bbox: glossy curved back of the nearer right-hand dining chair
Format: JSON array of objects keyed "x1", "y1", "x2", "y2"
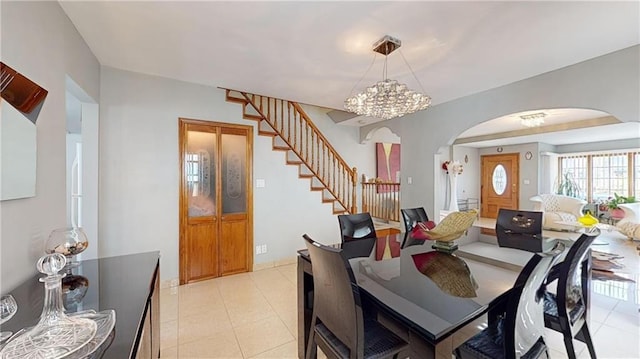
[{"x1": 504, "y1": 242, "x2": 565, "y2": 358}]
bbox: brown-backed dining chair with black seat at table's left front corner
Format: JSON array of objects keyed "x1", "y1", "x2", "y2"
[{"x1": 303, "y1": 234, "x2": 408, "y2": 359}]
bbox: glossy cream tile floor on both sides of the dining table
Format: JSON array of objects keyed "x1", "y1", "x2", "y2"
[{"x1": 161, "y1": 232, "x2": 640, "y2": 359}]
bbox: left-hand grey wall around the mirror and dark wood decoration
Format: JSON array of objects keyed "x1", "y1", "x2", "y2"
[{"x1": 0, "y1": 1, "x2": 100, "y2": 293}]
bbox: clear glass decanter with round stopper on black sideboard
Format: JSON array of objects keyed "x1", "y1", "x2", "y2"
[{"x1": 0, "y1": 253, "x2": 97, "y2": 359}]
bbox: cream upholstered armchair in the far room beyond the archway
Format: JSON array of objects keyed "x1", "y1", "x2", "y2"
[{"x1": 529, "y1": 194, "x2": 587, "y2": 231}]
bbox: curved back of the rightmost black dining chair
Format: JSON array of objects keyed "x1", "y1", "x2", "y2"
[{"x1": 554, "y1": 230, "x2": 600, "y2": 334}]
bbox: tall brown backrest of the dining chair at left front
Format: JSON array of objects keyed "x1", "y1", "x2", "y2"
[{"x1": 303, "y1": 234, "x2": 364, "y2": 357}]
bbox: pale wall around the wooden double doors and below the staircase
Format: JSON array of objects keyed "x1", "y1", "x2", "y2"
[{"x1": 99, "y1": 67, "x2": 375, "y2": 280}]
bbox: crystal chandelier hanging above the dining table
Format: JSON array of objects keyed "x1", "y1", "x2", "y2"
[{"x1": 344, "y1": 35, "x2": 431, "y2": 120}]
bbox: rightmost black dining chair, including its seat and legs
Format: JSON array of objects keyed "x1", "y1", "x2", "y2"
[{"x1": 544, "y1": 230, "x2": 600, "y2": 359}]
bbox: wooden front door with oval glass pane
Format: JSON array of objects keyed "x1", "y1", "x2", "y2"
[{"x1": 480, "y1": 153, "x2": 520, "y2": 222}]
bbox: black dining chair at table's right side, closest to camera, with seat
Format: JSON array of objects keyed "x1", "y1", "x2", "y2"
[{"x1": 454, "y1": 243, "x2": 564, "y2": 359}]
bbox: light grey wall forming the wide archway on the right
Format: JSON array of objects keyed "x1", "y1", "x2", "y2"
[{"x1": 360, "y1": 46, "x2": 640, "y2": 219}]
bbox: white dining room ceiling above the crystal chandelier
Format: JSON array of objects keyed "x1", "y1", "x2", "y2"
[{"x1": 61, "y1": 1, "x2": 640, "y2": 142}]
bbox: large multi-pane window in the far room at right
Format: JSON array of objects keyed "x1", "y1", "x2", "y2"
[{"x1": 559, "y1": 152, "x2": 640, "y2": 202}]
